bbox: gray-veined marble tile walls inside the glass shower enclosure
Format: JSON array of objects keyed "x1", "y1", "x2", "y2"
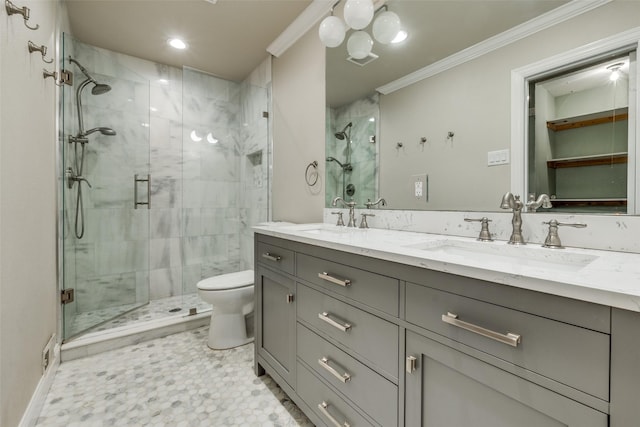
[{"x1": 61, "y1": 38, "x2": 269, "y2": 332}]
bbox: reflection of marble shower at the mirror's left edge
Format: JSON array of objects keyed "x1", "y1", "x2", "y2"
[{"x1": 325, "y1": 95, "x2": 379, "y2": 207}]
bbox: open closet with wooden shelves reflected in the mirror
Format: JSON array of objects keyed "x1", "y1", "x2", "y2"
[{"x1": 527, "y1": 52, "x2": 633, "y2": 213}]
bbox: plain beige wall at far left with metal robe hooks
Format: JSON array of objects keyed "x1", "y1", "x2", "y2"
[{"x1": 0, "y1": 1, "x2": 58, "y2": 426}]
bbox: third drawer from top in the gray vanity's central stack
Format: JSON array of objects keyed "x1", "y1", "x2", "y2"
[{"x1": 297, "y1": 323, "x2": 398, "y2": 426}]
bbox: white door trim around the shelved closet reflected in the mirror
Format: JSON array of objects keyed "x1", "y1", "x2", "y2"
[{"x1": 511, "y1": 27, "x2": 640, "y2": 215}]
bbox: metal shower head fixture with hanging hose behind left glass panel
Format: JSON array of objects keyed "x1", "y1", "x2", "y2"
[{"x1": 65, "y1": 57, "x2": 116, "y2": 239}]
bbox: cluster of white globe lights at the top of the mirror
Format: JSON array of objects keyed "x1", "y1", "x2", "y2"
[{"x1": 318, "y1": 0, "x2": 407, "y2": 65}]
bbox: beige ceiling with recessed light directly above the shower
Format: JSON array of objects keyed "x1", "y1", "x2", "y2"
[{"x1": 65, "y1": 0, "x2": 311, "y2": 81}]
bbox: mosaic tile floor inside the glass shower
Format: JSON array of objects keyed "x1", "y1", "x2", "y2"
[{"x1": 69, "y1": 293, "x2": 211, "y2": 335}]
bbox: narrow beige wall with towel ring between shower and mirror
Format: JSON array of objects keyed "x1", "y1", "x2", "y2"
[{"x1": 273, "y1": 28, "x2": 325, "y2": 222}]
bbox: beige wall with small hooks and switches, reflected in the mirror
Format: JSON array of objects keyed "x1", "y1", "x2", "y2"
[{"x1": 380, "y1": 0, "x2": 640, "y2": 211}]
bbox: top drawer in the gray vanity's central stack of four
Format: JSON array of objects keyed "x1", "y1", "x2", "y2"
[{"x1": 296, "y1": 254, "x2": 400, "y2": 316}]
